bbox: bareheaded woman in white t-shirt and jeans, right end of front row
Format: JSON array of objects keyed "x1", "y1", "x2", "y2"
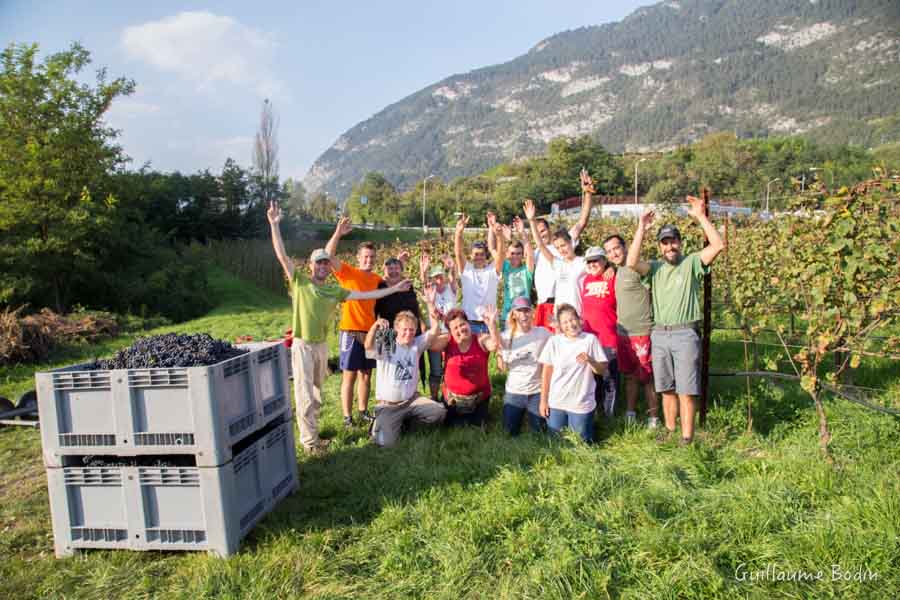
[{"x1": 538, "y1": 304, "x2": 606, "y2": 443}]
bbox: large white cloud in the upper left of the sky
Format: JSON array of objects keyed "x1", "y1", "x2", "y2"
[{"x1": 122, "y1": 12, "x2": 283, "y2": 98}]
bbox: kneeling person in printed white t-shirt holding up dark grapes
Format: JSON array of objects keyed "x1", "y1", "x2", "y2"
[{"x1": 365, "y1": 286, "x2": 447, "y2": 446}]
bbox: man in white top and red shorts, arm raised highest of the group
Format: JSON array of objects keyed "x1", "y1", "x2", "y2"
[{"x1": 534, "y1": 169, "x2": 594, "y2": 331}]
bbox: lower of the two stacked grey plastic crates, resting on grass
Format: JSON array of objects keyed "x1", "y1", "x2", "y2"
[{"x1": 47, "y1": 419, "x2": 298, "y2": 557}]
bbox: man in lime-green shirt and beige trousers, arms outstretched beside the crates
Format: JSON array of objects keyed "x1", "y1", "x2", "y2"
[{"x1": 266, "y1": 202, "x2": 410, "y2": 454}]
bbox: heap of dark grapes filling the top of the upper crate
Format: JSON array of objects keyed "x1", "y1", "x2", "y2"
[{"x1": 87, "y1": 333, "x2": 249, "y2": 370}]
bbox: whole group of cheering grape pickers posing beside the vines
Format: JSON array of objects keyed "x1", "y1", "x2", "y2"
[{"x1": 268, "y1": 171, "x2": 724, "y2": 453}]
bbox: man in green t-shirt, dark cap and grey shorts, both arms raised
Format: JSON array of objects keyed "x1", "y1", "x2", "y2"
[{"x1": 626, "y1": 196, "x2": 725, "y2": 444}]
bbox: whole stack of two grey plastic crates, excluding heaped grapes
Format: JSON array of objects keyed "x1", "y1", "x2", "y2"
[{"x1": 35, "y1": 342, "x2": 298, "y2": 556}]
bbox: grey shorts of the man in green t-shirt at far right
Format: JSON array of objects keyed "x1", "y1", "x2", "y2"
[{"x1": 650, "y1": 329, "x2": 700, "y2": 396}]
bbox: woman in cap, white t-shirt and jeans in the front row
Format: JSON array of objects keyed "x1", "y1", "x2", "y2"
[{"x1": 497, "y1": 296, "x2": 552, "y2": 435}]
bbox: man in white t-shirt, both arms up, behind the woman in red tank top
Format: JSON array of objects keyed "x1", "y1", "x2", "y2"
[{"x1": 453, "y1": 214, "x2": 506, "y2": 336}]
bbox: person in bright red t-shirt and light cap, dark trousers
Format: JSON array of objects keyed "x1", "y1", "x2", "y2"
[{"x1": 578, "y1": 246, "x2": 619, "y2": 417}]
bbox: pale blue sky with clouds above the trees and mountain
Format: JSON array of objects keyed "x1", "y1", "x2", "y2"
[{"x1": 0, "y1": 0, "x2": 653, "y2": 179}]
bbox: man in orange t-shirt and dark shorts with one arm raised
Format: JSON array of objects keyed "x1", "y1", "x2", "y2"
[{"x1": 325, "y1": 217, "x2": 381, "y2": 427}]
